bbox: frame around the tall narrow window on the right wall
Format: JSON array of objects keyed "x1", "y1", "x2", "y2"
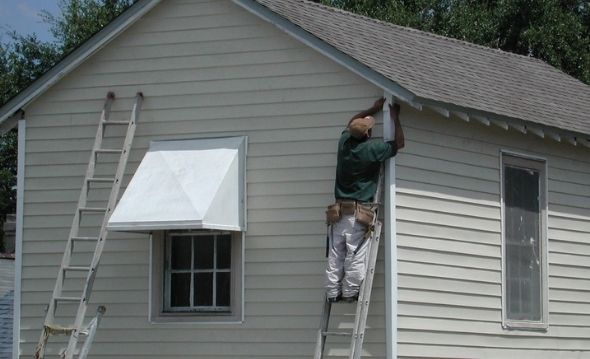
[{"x1": 500, "y1": 150, "x2": 549, "y2": 330}]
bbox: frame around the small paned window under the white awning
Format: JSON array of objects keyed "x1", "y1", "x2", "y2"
[{"x1": 153, "y1": 229, "x2": 245, "y2": 324}]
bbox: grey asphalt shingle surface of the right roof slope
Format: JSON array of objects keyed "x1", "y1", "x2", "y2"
[{"x1": 255, "y1": 0, "x2": 590, "y2": 134}]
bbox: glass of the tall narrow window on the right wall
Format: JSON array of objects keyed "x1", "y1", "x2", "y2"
[{"x1": 504, "y1": 166, "x2": 541, "y2": 321}]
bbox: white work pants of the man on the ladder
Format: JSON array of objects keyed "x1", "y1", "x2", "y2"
[{"x1": 325, "y1": 215, "x2": 369, "y2": 298}]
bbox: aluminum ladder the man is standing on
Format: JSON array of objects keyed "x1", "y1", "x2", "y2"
[{"x1": 314, "y1": 166, "x2": 384, "y2": 359}]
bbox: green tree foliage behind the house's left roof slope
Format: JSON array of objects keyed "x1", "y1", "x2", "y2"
[{"x1": 0, "y1": 0, "x2": 133, "y2": 252}]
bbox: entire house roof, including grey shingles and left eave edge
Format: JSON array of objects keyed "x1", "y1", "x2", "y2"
[{"x1": 0, "y1": 0, "x2": 590, "y2": 141}]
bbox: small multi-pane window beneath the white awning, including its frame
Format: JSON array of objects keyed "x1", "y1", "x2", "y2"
[{"x1": 151, "y1": 230, "x2": 242, "y2": 322}]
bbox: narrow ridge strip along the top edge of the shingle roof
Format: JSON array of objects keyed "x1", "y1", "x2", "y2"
[{"x1": 298, "y1": 0, "x2": 545, "y2": 64}]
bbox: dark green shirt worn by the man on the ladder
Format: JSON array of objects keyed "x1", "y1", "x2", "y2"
[{"x1": 334, "y1": 130, "x2": 397, "y2": 202}]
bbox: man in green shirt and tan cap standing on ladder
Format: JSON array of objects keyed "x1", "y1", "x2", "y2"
[{"x1": 325, "y1": 98, "x2": 404, "y2": 303}]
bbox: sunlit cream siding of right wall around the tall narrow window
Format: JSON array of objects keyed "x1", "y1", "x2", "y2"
[{"x1": 397, "y1": 108, "x2": 590, "y2": 358}]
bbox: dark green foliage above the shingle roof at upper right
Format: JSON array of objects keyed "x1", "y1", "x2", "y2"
[{"x1": 321, "y1": 0, "x2": 590, "y2": 84}]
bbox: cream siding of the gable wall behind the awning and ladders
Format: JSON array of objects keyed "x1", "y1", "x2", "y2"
[{"x1": 21, "y1": 0, "x2": 384, "y2": 359}]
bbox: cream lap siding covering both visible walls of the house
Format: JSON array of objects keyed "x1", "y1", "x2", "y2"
[{"x1": 15, "y1": 0, "x2": 590, "y2": 359}]
